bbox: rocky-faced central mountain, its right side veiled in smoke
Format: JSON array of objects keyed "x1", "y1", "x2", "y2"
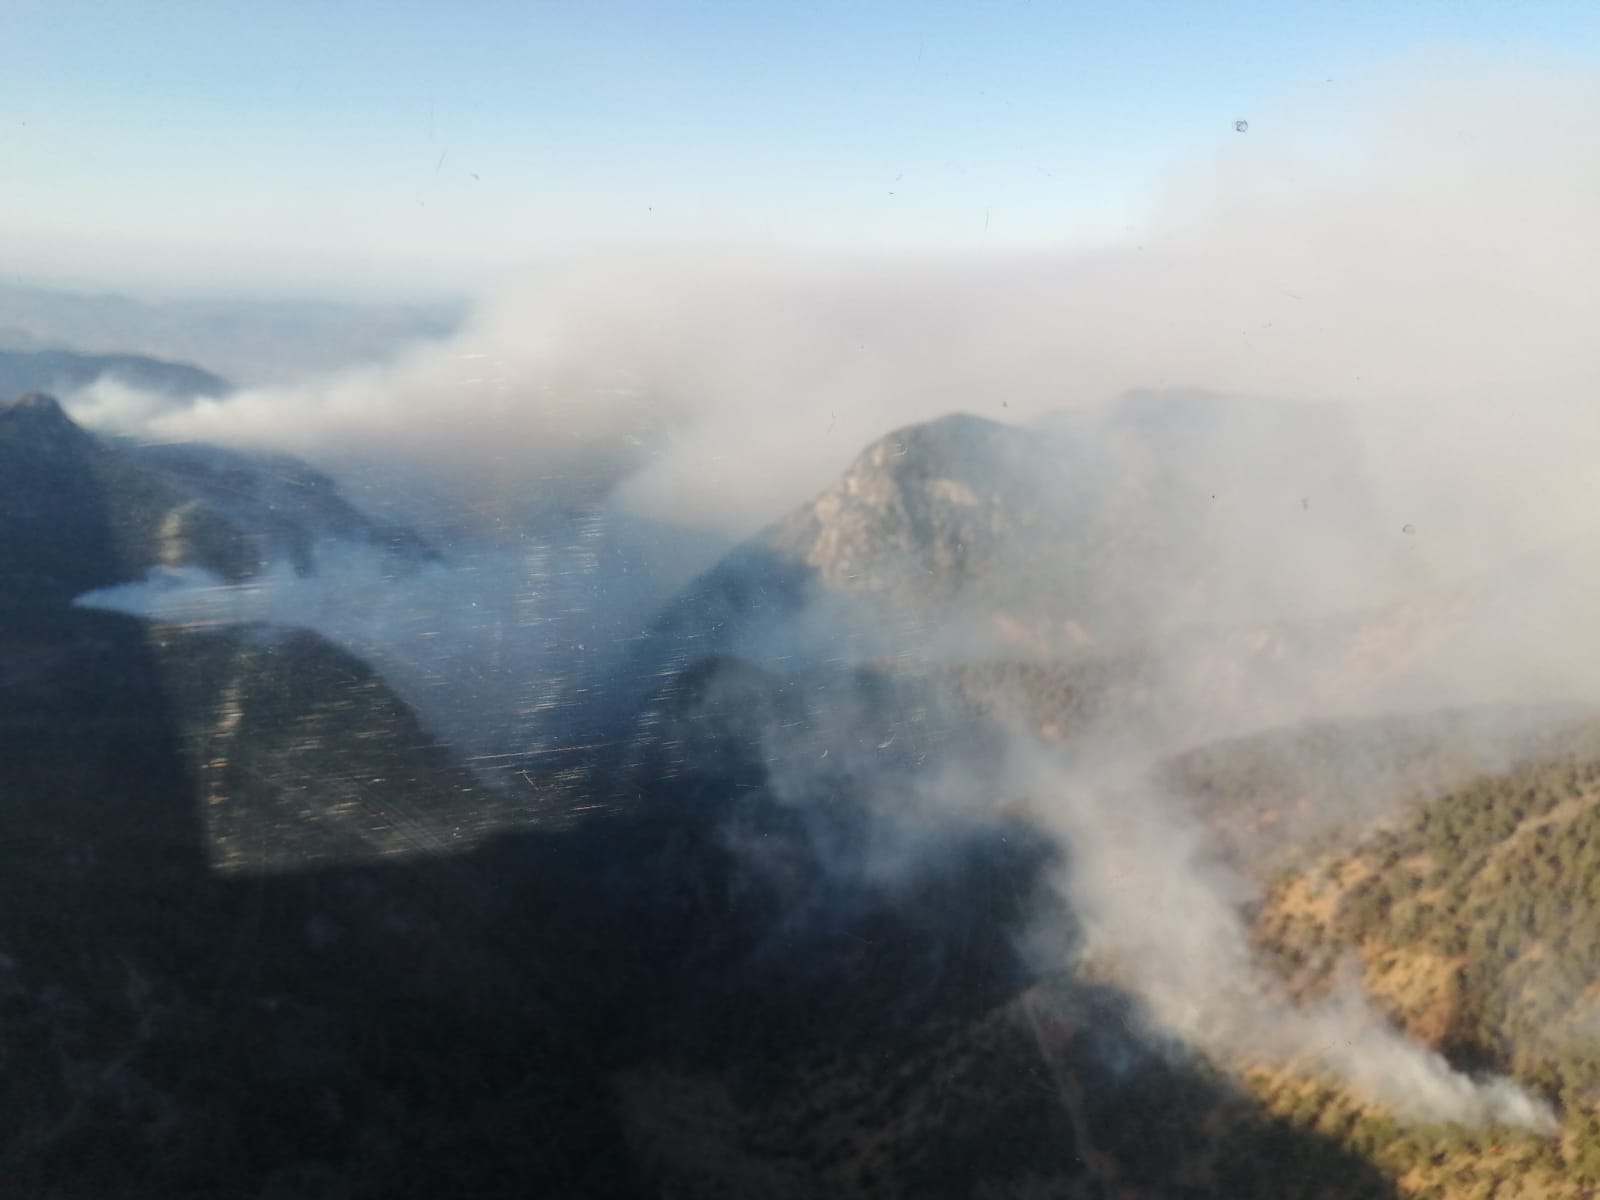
[{"x1": 646, "y1": 392, "x2": 1408, "y2": 678}]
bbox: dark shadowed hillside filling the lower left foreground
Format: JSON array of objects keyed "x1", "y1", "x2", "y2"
[{"x1": 0, "y1": 396, "x2": 1414, "y2": 1200}]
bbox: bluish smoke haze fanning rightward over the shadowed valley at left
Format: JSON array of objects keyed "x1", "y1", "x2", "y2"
[{"x1": 82, "y1": 528, "x2": 713, "y2": 779}]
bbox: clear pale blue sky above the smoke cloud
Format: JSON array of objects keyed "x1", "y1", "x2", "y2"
[{"x1": 0, "y1": 0, "x2": 1600, "y2": 290}]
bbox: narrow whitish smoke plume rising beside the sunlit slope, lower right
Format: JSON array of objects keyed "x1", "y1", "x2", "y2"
[{"x1": 1019, "y1": 752, "x2": 1555, "y2": 1133}]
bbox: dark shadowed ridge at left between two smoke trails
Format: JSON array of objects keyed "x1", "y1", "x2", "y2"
[{"x1": 0, "y1": 394, "x2": 427, "y2": 605}]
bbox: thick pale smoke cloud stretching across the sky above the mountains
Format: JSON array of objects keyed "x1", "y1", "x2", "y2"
[{"x1": 68, "y1": 62, "x2": 1600, "y2": 558}]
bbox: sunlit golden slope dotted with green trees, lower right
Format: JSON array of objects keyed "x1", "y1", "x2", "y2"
[{"x1": 1250, "y1": 731, "x2": 1600, "y2": 1197}]
